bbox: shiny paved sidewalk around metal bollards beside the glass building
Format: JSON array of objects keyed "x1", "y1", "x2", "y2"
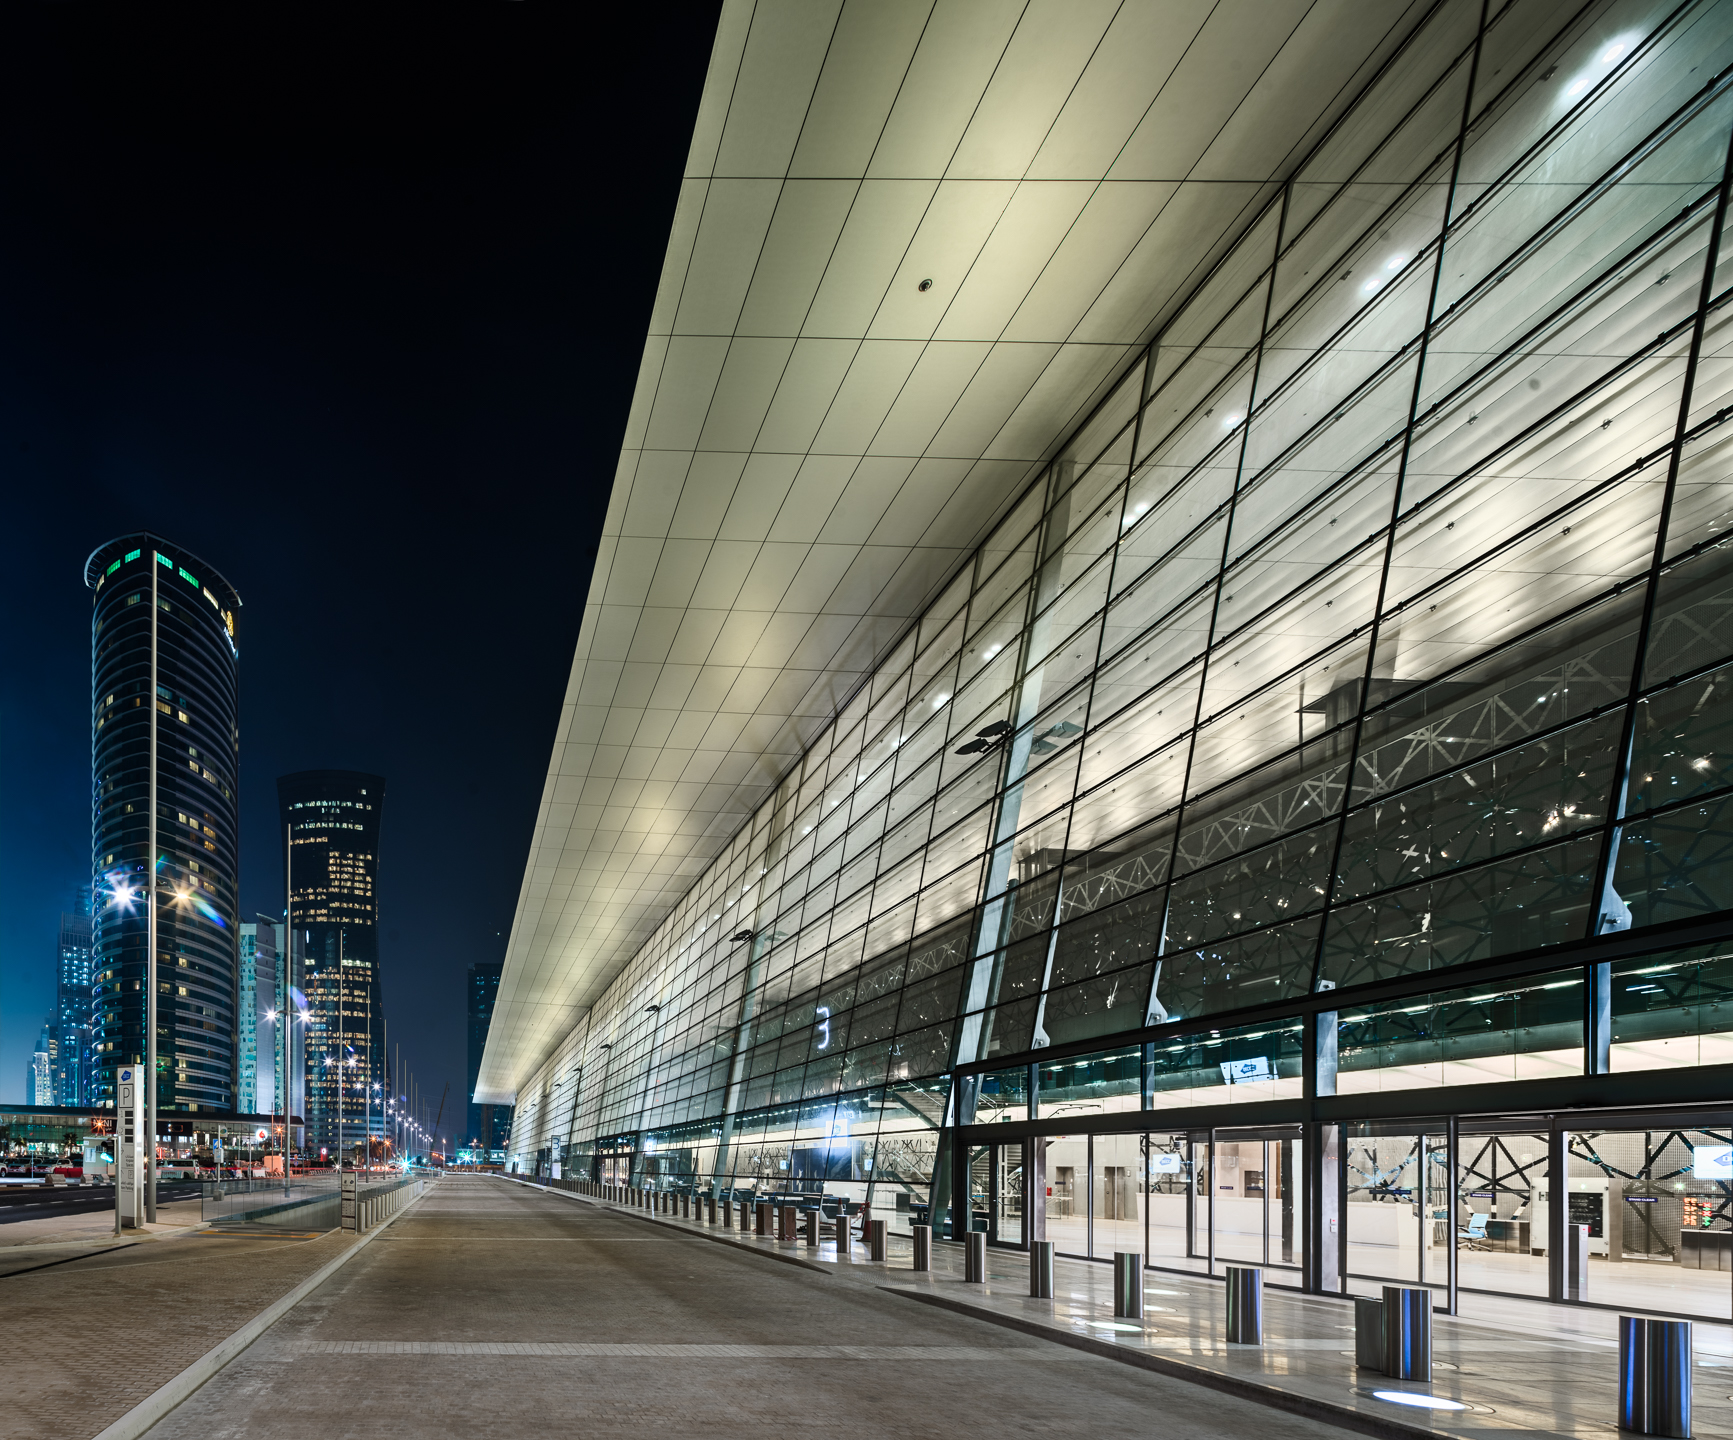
[{"x1": 523, "y1": 1182, "x2": 1733, "y2": 1440}]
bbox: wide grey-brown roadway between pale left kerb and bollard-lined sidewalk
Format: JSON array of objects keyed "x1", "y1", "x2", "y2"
[{"x1": 151, "y1": 1177, "x2": 1340, "y2": 1440}]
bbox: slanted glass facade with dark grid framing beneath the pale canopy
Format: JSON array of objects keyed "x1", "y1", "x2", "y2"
[{"x1": 511, "y1": 0, "x2": 1733, "y2": 1310}]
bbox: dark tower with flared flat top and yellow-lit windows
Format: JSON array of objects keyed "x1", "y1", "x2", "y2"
[{"x1": 277, "y1": 769, "x2": 385, "y2": 1156}]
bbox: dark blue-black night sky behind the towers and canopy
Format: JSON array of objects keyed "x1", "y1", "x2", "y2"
[{"x1": 0, "y1": 2, "x2": 714, "y2": 1133}]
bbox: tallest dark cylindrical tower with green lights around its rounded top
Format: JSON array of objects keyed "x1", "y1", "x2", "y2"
[{"x1": 85, "y1": 534, "x2": 241, "y2": 1112}]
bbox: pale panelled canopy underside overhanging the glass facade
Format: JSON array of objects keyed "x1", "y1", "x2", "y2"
[{"x1": 473, "y1": 0, "x2": 1425, "y2": 1104}]
